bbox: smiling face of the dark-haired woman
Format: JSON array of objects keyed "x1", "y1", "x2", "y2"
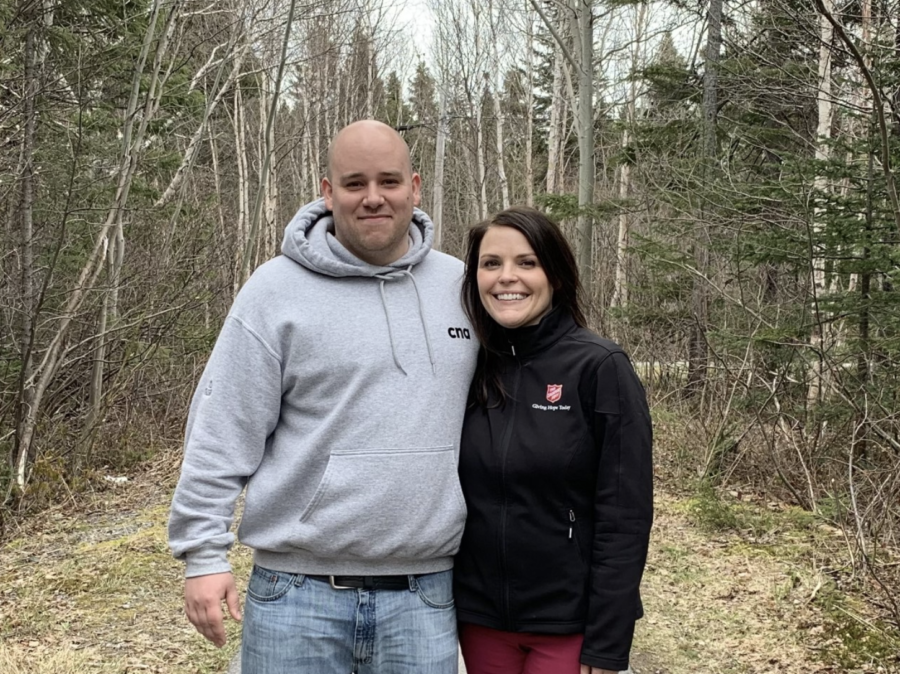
[{"x1": 477, "y1": 225, "x2": 553, "y2": 328}]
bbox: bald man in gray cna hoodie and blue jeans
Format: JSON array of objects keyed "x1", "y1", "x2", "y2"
[{"x1": 169, "y1": 121, "x2": 477, "y2": 674}]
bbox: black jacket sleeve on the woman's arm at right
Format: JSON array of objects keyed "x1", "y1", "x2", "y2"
[{"x1": 581, "y1": 352, "x2": 653, "y2": 671}]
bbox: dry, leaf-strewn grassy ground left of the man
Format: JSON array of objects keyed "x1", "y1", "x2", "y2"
[{"x1": 0, "y1": 452, "x2": 250, "y2": 674}]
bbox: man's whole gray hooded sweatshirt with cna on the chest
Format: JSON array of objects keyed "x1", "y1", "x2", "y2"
[{"x1": 169, "y1": 200, "x2": 477, "y2": 577}]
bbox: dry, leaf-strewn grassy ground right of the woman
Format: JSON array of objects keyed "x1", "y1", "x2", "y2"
[{"x1": 636, "y1": 489, "x2": 900, "y2": 674}]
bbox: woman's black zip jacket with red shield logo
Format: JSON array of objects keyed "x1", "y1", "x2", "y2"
[{"x1": 454, "y1": 309, "x2": 653, "y2": 671}]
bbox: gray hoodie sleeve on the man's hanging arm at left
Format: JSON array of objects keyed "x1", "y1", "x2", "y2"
[{"x1": 169, "y1": 315, "x2": 282, "y2": 578}]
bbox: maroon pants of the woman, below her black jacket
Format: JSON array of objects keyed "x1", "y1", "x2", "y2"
[{"x1": 459, "y1": 623, "x2": 584, "y2": 674}]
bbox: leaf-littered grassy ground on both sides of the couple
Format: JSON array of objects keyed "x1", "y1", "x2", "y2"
[{"x1": 0, "y1": 454, "x2": 900, "y2": 674}]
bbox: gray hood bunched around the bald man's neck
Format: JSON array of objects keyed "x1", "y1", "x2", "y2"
[{"x1": 281, "y1": 199, "x2": 434, "y2": 277}]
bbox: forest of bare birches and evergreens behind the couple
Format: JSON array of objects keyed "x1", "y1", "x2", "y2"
[{"x1": 0, "y1": 0, "x2": 900, "y2": 668}]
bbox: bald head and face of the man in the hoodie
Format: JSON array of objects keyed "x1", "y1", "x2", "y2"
[{"x1": 322, "y1": 122, "x2": 421, "y2": 266}]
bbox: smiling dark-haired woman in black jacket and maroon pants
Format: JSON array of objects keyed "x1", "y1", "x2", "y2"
[{"x1": 454, "y1": 207, "x2": 653, "y2": 674}]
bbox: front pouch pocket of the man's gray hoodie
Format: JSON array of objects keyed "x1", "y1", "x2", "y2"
[{"x1": 294, "y1": 446, "x2": 466, "y2": 559}]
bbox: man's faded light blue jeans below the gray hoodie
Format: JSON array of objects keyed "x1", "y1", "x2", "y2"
[{"x1": 241, "y1": 566, "x2": 458, "y2": 674}]
